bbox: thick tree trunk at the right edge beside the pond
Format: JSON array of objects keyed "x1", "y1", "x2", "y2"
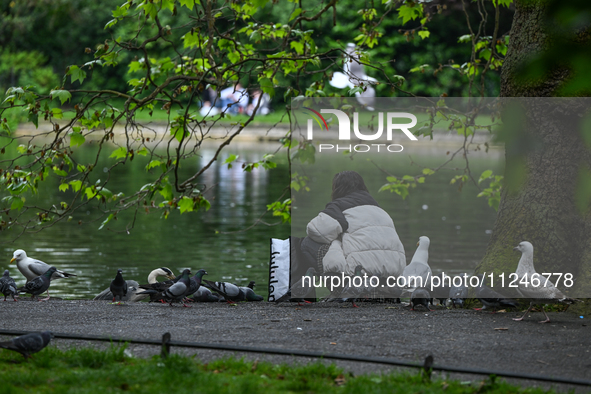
[{"x1": 477, "y1": 1, "x2": 591, "y2": 304}]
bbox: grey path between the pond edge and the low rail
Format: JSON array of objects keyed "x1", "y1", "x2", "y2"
[{"x1": 0, "y1": 299, "x2": 591, "y2": 392}]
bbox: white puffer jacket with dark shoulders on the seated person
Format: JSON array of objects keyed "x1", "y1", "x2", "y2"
[{"x1": 306, "y1": 191, "x2": 406, "y2": 277}]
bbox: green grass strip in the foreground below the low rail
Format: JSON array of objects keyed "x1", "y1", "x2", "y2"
[{"x1": 0, "y1": 346, "x2": 551, "y2": 394}]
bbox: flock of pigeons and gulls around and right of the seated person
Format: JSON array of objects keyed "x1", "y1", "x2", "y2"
[{"x1": 276, "y1": 236, "x2": 580, "y2": 323}]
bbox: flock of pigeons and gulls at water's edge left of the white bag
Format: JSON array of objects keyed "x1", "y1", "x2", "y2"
[{"x1": 0, "y1": 249, "x2": 263, "y2": 306}]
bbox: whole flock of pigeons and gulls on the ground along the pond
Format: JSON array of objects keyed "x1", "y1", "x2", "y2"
[{"x1": 0, "y1": 236, "x2": 580, "y2": 359}]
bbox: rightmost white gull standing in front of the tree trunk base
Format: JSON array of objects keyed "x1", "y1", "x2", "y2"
[{"x1": 513, "y1": 241, "x2": 581, "y2": 323}]
